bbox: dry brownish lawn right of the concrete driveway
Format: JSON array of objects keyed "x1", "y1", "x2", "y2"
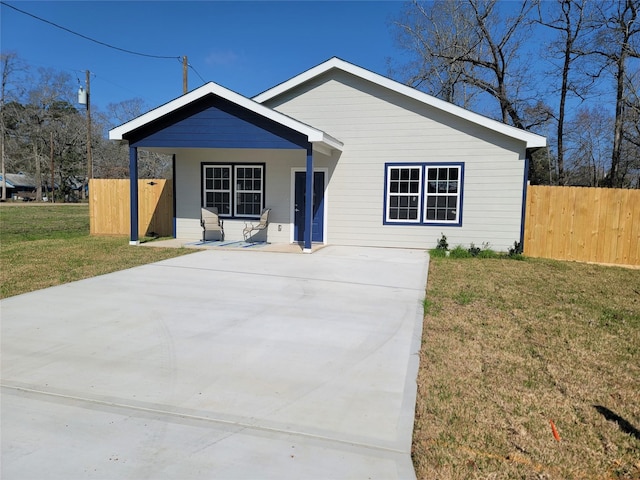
[{"x1": 413, "y1": 258, "x2": 640, "y2": 479}]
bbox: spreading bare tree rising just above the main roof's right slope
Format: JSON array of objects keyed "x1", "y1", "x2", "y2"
[{"x1": 394, "y1": 0, "x2": 551, "y2": 129}]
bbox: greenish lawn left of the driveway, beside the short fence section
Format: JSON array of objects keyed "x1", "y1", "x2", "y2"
[{"x1": 0, "y1": 204, "x2": 192, "y2": 298}]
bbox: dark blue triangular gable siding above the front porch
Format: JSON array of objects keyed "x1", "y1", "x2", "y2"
[{"x1": 124, "y1": 95, "x2": 308, "y2": 149}]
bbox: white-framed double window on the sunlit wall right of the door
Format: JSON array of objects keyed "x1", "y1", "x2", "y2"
[{"x1": 384, "y1": 163, "x2": 464, "y2": 226}]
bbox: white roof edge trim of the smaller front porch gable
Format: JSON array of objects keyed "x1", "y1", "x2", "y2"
[{"x1": 109, "y1": 82, "x2": 343, "y2": 150}]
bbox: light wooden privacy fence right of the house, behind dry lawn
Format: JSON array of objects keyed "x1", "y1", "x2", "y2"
[{"x1": 524, "y1": 186, "x2": 640, "y2": 265}]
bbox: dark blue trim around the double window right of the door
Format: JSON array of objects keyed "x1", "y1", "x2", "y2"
[{"x1": 382, "y1": 162, "x2": 464, "y2": 227}]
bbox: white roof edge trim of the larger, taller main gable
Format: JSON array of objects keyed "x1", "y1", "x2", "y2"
[{"x1": 253, "y1": 57, "x2": 547, "y2": 148}]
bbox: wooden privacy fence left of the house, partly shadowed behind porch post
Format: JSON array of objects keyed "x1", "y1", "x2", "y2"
[{"x1": 89, "y1": 179, "x2": 173, "y2": 237}]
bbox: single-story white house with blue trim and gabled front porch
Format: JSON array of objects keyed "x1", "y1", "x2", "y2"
[{"x1": 109, "y1": 58, "x2": 546, "y2": 251}]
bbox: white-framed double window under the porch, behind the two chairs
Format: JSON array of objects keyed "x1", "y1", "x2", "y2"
[{"x1": 202, "y1": 164, "x2": 264, "y2": 217}]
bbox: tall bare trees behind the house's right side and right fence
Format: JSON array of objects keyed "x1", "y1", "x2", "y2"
[{"x1": 391, "y1": 0, "x2": 640, "y2": 188}]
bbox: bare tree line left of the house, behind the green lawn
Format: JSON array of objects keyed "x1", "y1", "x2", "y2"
[{"x1": 0, "y1": 52, "x2": 171, "y2": 200}]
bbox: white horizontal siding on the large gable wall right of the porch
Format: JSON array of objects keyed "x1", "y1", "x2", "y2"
[{"x1": 267, "y1": 71, "x2": 525, "y2": 250}]
